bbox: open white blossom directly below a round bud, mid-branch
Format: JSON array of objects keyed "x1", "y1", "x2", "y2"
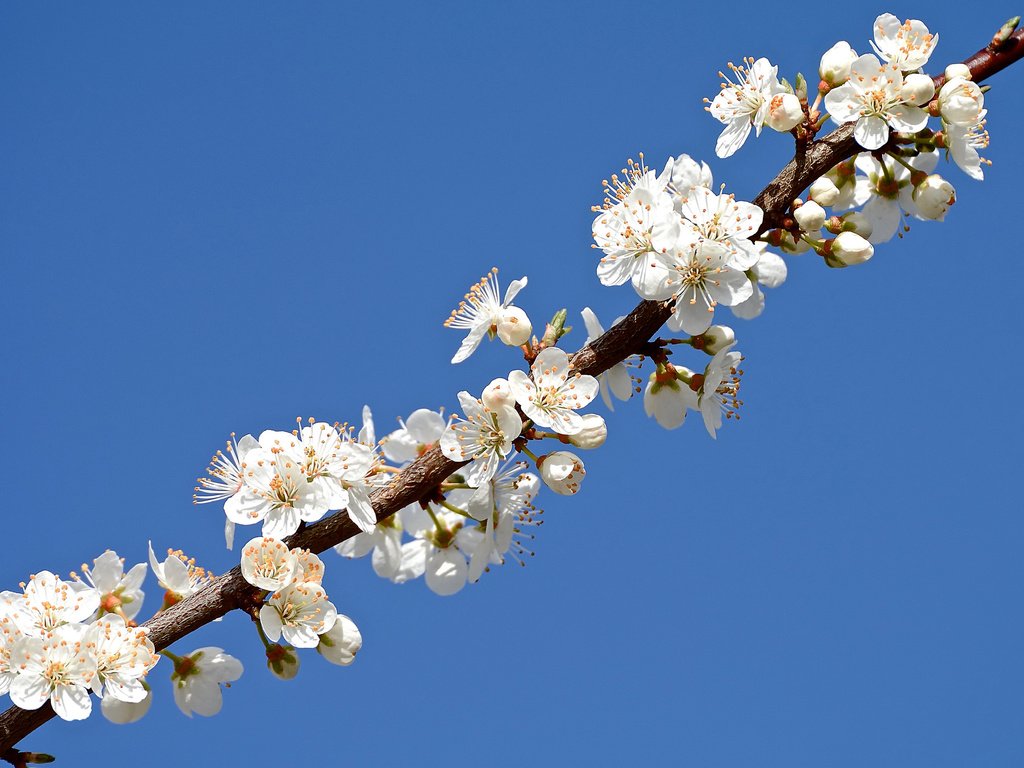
[{"x1": 440, "y1": 391, "x2": 522, "y2": 487}]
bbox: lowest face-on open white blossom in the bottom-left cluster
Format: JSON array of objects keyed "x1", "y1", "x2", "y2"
[{"x1": 10, "y1": 625, "x2": 96, "y2": 720}]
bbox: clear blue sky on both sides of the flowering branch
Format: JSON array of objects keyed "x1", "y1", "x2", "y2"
[{"x1": 0, "y1": 2, "x2": 1024, "y2": 768}]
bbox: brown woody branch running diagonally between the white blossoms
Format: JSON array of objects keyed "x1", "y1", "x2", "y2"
[{"x1": 0, "y1": 18, "x2": 1024, "y2": 755}]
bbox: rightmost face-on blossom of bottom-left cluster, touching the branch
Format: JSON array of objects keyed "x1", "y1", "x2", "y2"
[{"x1": 83, "y1": 615, "x2": 160, "y2": 703}]
